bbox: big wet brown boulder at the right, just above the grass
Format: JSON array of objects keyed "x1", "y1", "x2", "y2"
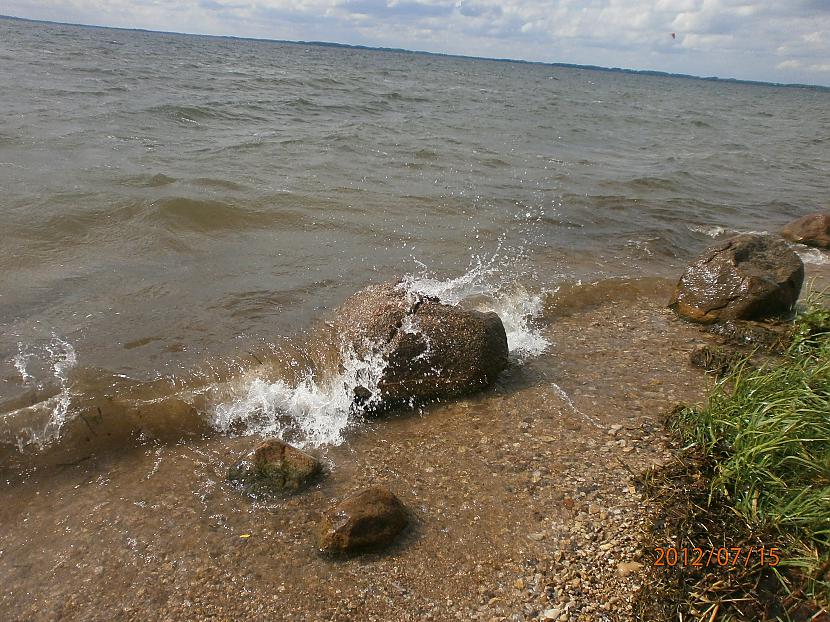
[{"x1": 670, "y1": 234, "x2": 804, "y2": 324}]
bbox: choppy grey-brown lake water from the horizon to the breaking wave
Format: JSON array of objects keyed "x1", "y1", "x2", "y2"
[{"x1": 0, "y1": 19, "x2": 830, "y2": 460}]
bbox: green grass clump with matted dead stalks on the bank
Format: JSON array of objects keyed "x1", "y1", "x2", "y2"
[{"x1": 643, "y1": 296, "x2": 830, "y2": 622}]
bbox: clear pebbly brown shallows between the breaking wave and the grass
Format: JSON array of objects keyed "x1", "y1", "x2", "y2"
[{"x1": 0, "y1": 283, "x2": 728, "y2": 620}]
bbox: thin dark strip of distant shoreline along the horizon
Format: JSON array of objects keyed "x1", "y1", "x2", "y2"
[{"x1": 0, "y1": 15, "x2": 830, "y2": 92}]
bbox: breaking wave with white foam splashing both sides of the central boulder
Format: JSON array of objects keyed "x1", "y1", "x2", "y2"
[{"x1": 0, "y1": 257, "x2": 550, "y2": 460}]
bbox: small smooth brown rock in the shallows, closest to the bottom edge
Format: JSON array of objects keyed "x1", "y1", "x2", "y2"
[{"x1": 319, "y1": 486, "x2": 409, "y2": 554}]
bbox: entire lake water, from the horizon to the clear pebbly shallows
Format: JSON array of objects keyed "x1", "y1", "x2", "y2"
[{"x1": 0, "y1": 19, "x2": 830, "y2": 621}]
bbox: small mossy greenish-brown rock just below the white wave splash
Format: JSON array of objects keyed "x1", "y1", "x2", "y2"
[{"x1": 228, "y1": 439, "x2": 322, "y2": 497}]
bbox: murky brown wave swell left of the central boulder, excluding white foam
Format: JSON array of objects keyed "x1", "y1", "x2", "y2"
[{"x1": 0, "y1": 330, "x2": 340, "y2": 469}]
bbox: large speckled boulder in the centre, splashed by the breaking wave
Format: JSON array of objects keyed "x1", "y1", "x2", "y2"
[{"x1": 334, "y1": 282, "x2": 507, "y2": 410}]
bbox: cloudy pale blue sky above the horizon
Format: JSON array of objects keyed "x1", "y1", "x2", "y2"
[{"x1": 0, "y1": 0, "x2": 830, "y2": 86}]
